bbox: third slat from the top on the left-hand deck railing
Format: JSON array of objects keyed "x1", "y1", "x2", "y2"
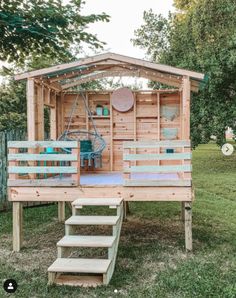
[{"x1": 8, "y1": 166, "x2": 78, "y2": 174}]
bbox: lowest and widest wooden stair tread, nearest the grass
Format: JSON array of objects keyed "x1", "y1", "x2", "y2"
[{"x1": 48, "y1": 258, "x2": 111, "y2": 274}]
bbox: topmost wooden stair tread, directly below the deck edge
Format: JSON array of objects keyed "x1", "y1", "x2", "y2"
[{"x1": 72, "y1": 198, "x2": 123, "y2": 208}]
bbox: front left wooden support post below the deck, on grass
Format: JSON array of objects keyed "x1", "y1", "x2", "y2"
[{"x1": 12, "y1": 202, "x2": 23, "y2": 251}]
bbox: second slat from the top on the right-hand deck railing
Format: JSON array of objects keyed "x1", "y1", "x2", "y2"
[{"x1": 123, "y1": 152, "x2": 192, "y2": 160}]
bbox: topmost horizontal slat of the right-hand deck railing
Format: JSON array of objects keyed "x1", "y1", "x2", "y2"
[{"x1": 123, "y1": 140, "x2": 191, "y2": 149}]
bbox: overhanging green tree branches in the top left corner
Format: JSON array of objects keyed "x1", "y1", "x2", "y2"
[{"x1": 0, "y1": 0, "x2": 109, "y2": 63}]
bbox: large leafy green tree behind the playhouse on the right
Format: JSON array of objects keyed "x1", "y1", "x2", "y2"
[{"x1": 133, "y1": 0, "x2": 236, "y2": 146}]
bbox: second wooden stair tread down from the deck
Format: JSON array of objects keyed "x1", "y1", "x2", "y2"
[{"x1": 65, "y1": 215, "x2": 120, "y2": 226}]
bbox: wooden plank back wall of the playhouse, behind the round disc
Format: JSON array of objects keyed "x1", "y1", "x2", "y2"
[{"x1": 62, "y1": 90, "x2": 182, "y2": 171}]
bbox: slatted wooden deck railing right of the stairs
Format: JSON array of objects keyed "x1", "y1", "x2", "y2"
[{"x1": 123, "y1": 140, "x2": 192, "y2": 186}]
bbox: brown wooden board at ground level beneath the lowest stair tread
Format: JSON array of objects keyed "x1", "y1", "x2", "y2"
[{"x1": 55, "y1": 274, "x2": 103, "y2": 287}]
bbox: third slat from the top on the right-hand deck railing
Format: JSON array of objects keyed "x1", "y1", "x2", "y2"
[{"x1": 124, "y1": 165, "x2": 192, "y2": 173}]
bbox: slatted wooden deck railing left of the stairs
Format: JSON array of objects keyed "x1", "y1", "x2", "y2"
[{"x1": 8, "y1": 141, "x2": 80, "y2": 186}]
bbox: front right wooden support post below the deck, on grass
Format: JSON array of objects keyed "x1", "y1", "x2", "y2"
[{"x1": 184, "y1": 202, "x2": 193, "y2": 252}]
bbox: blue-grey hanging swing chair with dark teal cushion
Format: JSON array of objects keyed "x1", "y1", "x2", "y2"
[{"x1": 59, "y1": 92, "x2": 106, "y2": 168}]
